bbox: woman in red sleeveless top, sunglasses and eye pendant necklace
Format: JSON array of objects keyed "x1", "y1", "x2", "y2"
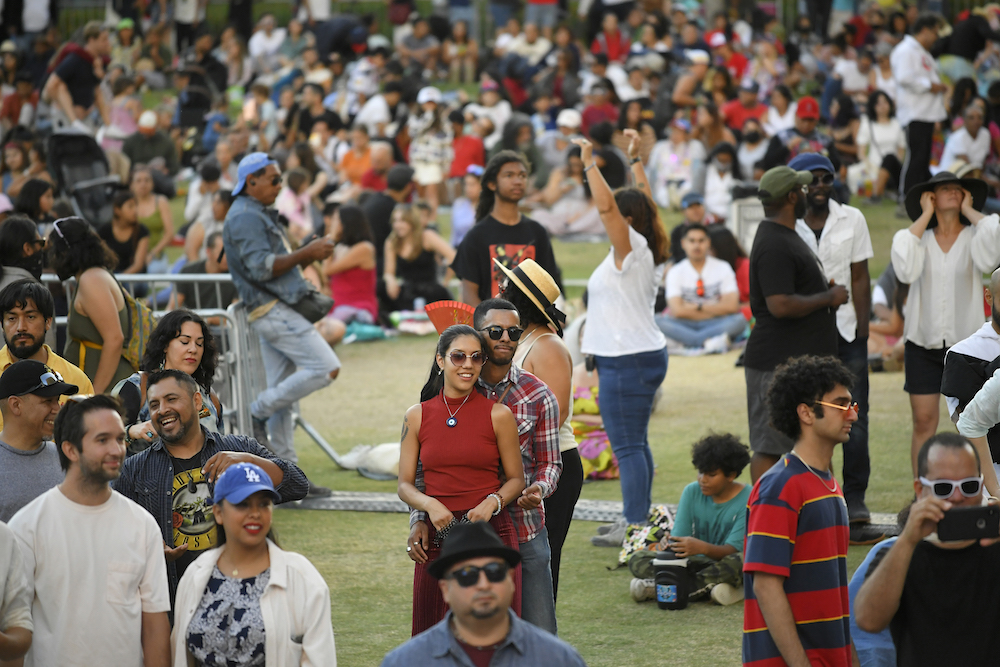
[{"x1": 398, "y1": 324, "x2": 524, "y2": 635}]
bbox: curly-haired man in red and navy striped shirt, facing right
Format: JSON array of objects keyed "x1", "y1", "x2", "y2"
[{"x1": 743, "y1": 356, "x2": 858, "y2": 667}]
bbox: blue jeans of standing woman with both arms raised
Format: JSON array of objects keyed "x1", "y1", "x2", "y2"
[{"x1": 595, "y1": 349, "x2": 667, "y2": 523}]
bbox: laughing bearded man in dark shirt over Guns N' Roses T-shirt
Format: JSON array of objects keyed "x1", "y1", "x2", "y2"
[{"x1": 114, "y1": 370, "x2": 309, "y2": 607}]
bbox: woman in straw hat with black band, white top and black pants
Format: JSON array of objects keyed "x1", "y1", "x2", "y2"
[{"x1": 500, "y1": 258, "x2": 583, "y2": 598}]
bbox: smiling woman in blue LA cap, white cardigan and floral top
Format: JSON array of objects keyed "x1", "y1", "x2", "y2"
[{"x1": 171, "y1": 463, "x2": 337, "y2": 667}]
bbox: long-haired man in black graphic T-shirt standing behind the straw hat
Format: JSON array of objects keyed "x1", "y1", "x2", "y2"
[{"x1": 451, "y1": 150, "x2": 560, "y2": 306}]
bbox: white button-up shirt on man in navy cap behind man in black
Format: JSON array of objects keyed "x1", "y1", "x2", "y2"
[{"x1": 795, "y1": 199, "x2": 875, "y2": 343}]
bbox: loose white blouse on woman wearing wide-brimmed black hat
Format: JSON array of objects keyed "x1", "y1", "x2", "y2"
[{"x1": 892, "y1": 214, "x2": 1000, "y2": 350}]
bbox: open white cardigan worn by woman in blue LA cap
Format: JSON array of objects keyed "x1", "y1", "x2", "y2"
[{"x1": 170, "y1": 540, "x2": 337, "y2": 667}]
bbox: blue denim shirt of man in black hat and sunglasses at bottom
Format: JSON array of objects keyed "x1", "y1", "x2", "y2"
[{"x1": 382, "y1": 609, "x2": 586, "y2": 667}]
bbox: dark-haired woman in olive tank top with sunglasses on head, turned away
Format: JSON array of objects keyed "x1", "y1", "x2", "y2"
[{"x1": 46, "y1": 217, "x2": 135, "y2": 394}]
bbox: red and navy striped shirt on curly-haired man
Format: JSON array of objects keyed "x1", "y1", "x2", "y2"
[{"x1": 743, "y1": 454, "x2": 851, "y2": 667}]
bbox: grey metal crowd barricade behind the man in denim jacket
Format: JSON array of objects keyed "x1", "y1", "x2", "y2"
[{"x1": 42, "y1": 273, "x2": 342, "y2": 467}]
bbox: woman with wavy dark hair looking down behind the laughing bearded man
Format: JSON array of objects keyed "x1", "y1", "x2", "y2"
[{"x1": 112, "y1": 309, "x2": 223, "y2": 453}]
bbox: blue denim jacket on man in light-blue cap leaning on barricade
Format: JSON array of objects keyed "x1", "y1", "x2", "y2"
[{"x1": 222, "y1": 196, "x2": 310, "y2": 310}]
